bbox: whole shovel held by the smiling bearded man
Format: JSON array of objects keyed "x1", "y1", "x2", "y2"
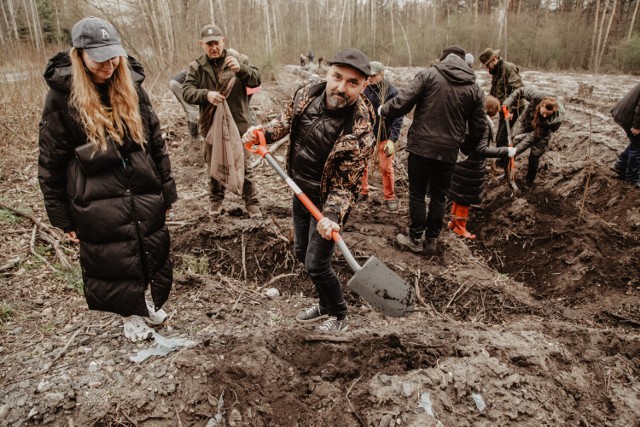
[{"x1": 245, "y1": 130, "x2": 415, "y2": 317}]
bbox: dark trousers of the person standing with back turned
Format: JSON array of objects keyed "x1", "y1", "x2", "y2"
[{"x1": 409, "y1": 153, "x2": 456, "y2": 239}]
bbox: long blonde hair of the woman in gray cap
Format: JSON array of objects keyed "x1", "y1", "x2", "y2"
[{"x1": 69, "y1": 48, "x2": 146, "y2": 150}]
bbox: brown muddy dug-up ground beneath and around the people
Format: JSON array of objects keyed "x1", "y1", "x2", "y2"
[{"x1": 0, "y1": 67, "x2": 640, "y2": 427}]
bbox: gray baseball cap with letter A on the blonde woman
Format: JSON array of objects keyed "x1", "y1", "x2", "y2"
[{"x1": 71, "y1": 16, "x2": 127, "y2": 62}]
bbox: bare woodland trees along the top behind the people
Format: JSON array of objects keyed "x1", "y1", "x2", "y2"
[{"x1": 0, "y1": 0, "x2": 640, "y2": 80}]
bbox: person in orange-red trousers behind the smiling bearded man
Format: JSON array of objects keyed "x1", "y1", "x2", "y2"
[{"x1": 360, "y1": 61, "x2": 402, "y2": 212}]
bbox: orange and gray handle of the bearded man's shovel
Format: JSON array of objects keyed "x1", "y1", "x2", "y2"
[{"x1": 244, "y1": 129, "x2": 362, "y2": 271}]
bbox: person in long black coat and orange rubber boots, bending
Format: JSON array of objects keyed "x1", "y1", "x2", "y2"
[{"x1": 447, "y1": 96, "x2": 516, "y2": 240}]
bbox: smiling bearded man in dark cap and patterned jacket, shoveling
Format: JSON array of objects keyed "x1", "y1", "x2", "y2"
[{"x1": 242, "y1": 49, "x2": 375, "y2": 332}]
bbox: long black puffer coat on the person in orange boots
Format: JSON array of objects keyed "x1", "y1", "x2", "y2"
[{"x1": 447, "y1": 117, "x2": 509, "y2": 206}]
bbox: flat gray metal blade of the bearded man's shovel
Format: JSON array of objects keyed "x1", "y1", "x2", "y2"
[{"x1": 349, "y1": 256, "x2": 415, "y2": 317}]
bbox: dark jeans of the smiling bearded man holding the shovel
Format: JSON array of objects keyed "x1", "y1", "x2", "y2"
[{"x1": 293, "y1": 197, "x2": 347, "y2": 319}]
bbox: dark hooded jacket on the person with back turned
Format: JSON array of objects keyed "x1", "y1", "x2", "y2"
[{"x1": 381, "y1": 55, "x2": 486, "y2": 163}]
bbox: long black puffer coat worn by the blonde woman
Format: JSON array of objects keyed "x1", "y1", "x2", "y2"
[{"x1": 38, "y1": 52, "x2": 177, "y2": 316}]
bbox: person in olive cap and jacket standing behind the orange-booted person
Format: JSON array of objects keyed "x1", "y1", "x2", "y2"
[{"x1": 478, "y1": 47, "x2": 524, "y2": 172}]
